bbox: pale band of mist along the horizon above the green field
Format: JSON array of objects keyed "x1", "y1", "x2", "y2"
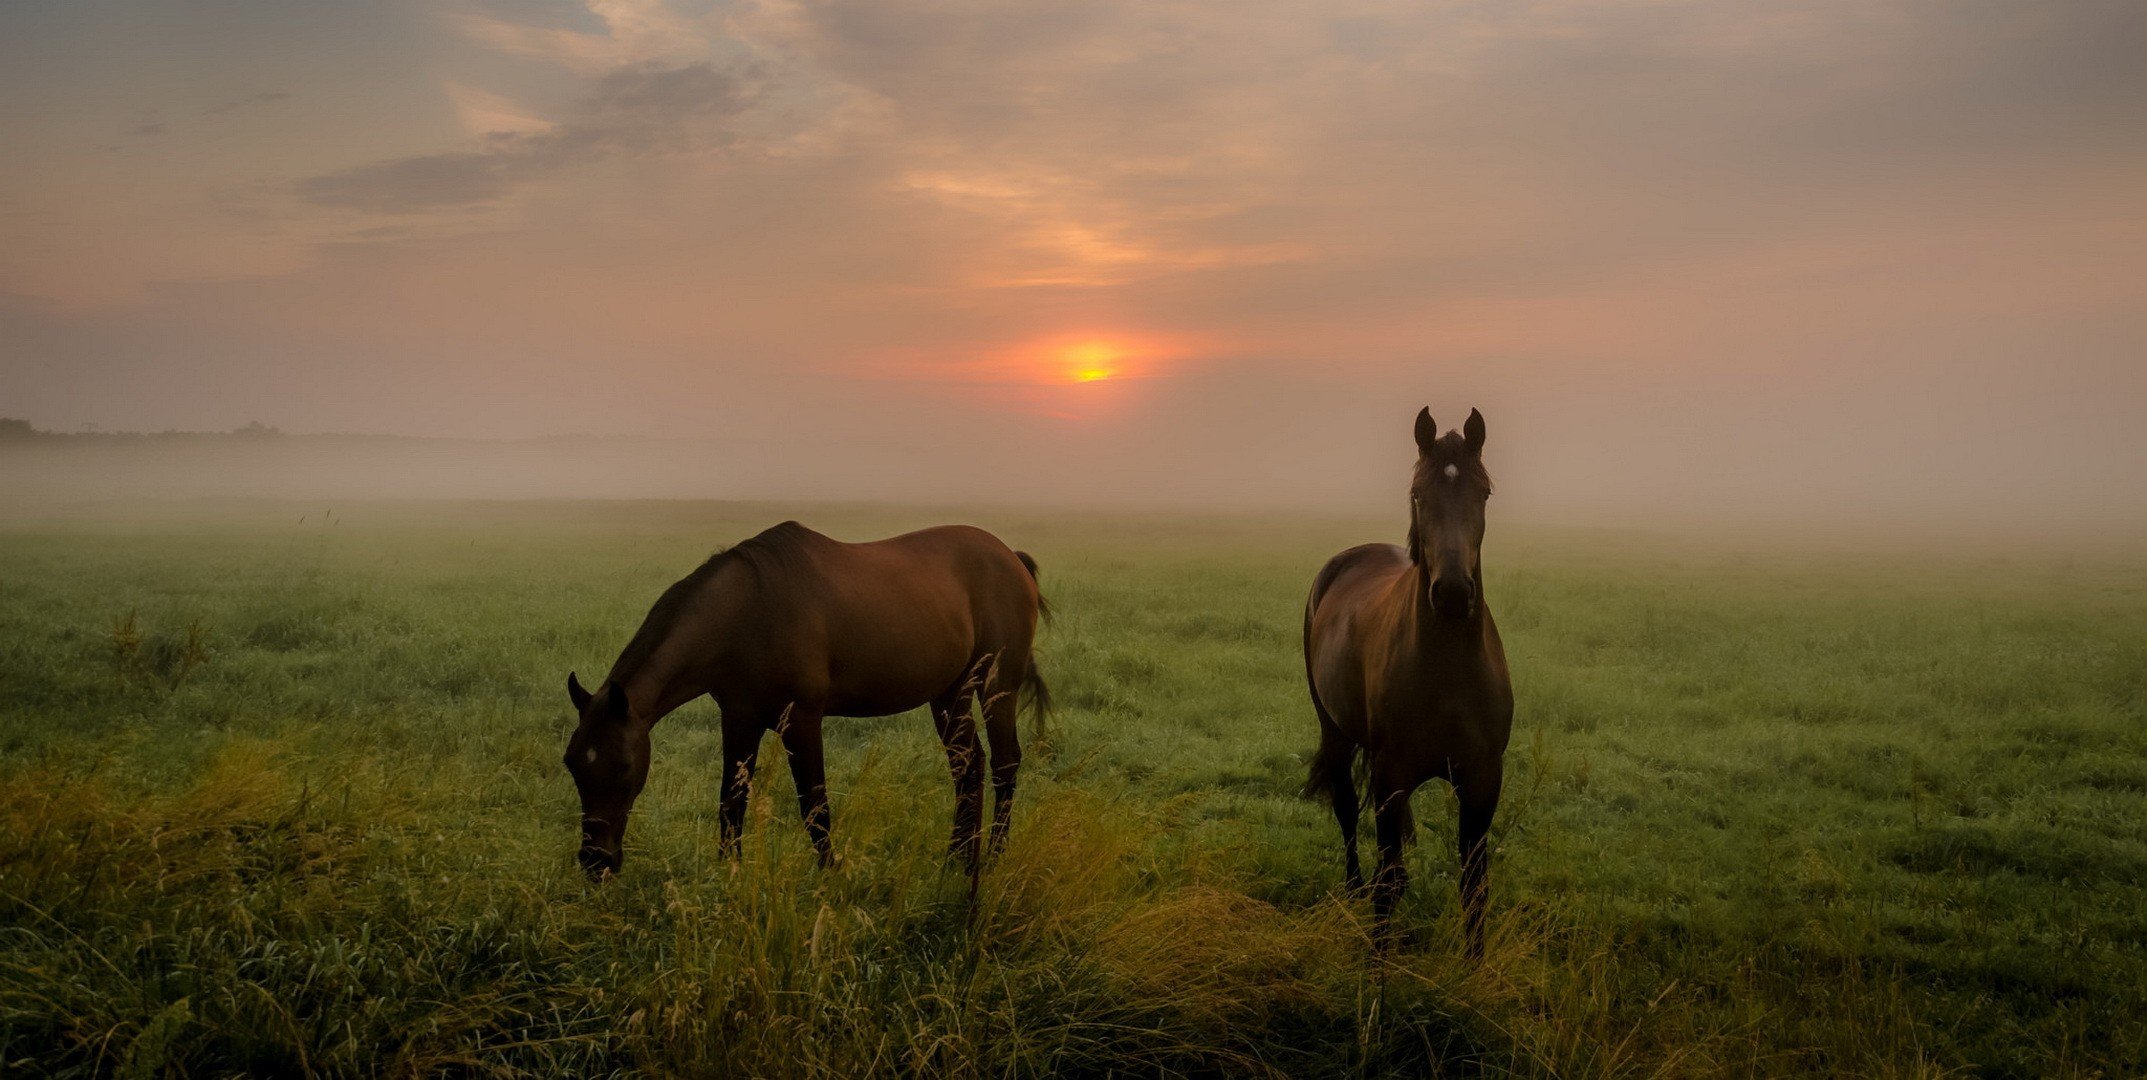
[{"x1": 0, "y1": 402, "x2": 2147, "y2": 541}]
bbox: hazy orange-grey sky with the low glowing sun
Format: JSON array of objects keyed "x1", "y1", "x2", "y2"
[{"x1": 0, "y1": 0, "x2": 2147, "y2": 515}]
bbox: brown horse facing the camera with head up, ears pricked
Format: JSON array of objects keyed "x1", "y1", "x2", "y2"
[{"x1": 1305, "y1": 408, "x2": 1514, "y2": 955}]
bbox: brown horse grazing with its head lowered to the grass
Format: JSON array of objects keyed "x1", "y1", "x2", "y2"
[{"x1": 567, "y1": 522, "x2": 1050, "y2": 878}]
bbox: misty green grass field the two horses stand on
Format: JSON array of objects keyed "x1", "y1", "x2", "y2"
[{"x1": 0, "y1": 502, "x2": 2147, "y2": 1076}]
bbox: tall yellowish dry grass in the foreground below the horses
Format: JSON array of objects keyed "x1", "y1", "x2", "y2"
[{"x1": 0, "y1": 743, "x2": 1975, "y2": 1078}]
